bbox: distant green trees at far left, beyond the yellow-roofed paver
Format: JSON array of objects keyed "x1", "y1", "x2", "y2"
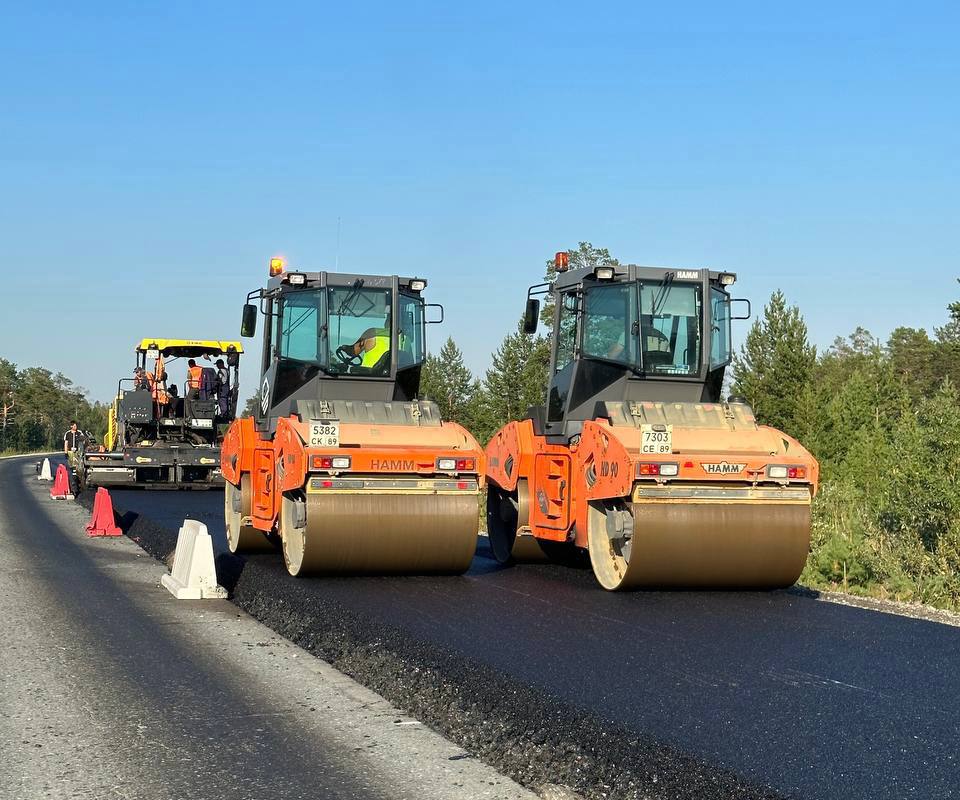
[{"x1": 0, "y1": 358, "x2": 107, "y2": 453}]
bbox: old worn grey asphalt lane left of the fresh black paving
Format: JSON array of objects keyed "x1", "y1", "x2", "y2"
[{"x1": 0, "y1": 459, "x2": 532, "y2": 800}]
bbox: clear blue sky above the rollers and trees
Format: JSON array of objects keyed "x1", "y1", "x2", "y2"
[{"x1": 0, "y1": 0, "x2": 960, "y2": 399}]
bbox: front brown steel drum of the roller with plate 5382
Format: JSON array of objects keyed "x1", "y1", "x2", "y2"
[{"x1": 280, "y1": 491, "x2": 480, "y2": 575}]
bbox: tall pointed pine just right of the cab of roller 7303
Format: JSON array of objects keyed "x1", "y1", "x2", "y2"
[{"x1": 734, "y1": 290, "x2": 817, "y2": 433}]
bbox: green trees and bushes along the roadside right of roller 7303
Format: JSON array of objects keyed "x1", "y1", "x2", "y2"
[{"x1": 734, "y1": 292, "x2": 960, "y2": 609}]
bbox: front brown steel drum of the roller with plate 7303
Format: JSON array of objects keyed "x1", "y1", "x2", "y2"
[{"x1": 590, "y1": 489, "x2": 810, "y2": 589}]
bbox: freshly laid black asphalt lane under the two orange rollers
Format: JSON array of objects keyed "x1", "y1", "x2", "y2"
[{"x1": 82, "y1": 472, "x2": 960, "y2": 800}]
